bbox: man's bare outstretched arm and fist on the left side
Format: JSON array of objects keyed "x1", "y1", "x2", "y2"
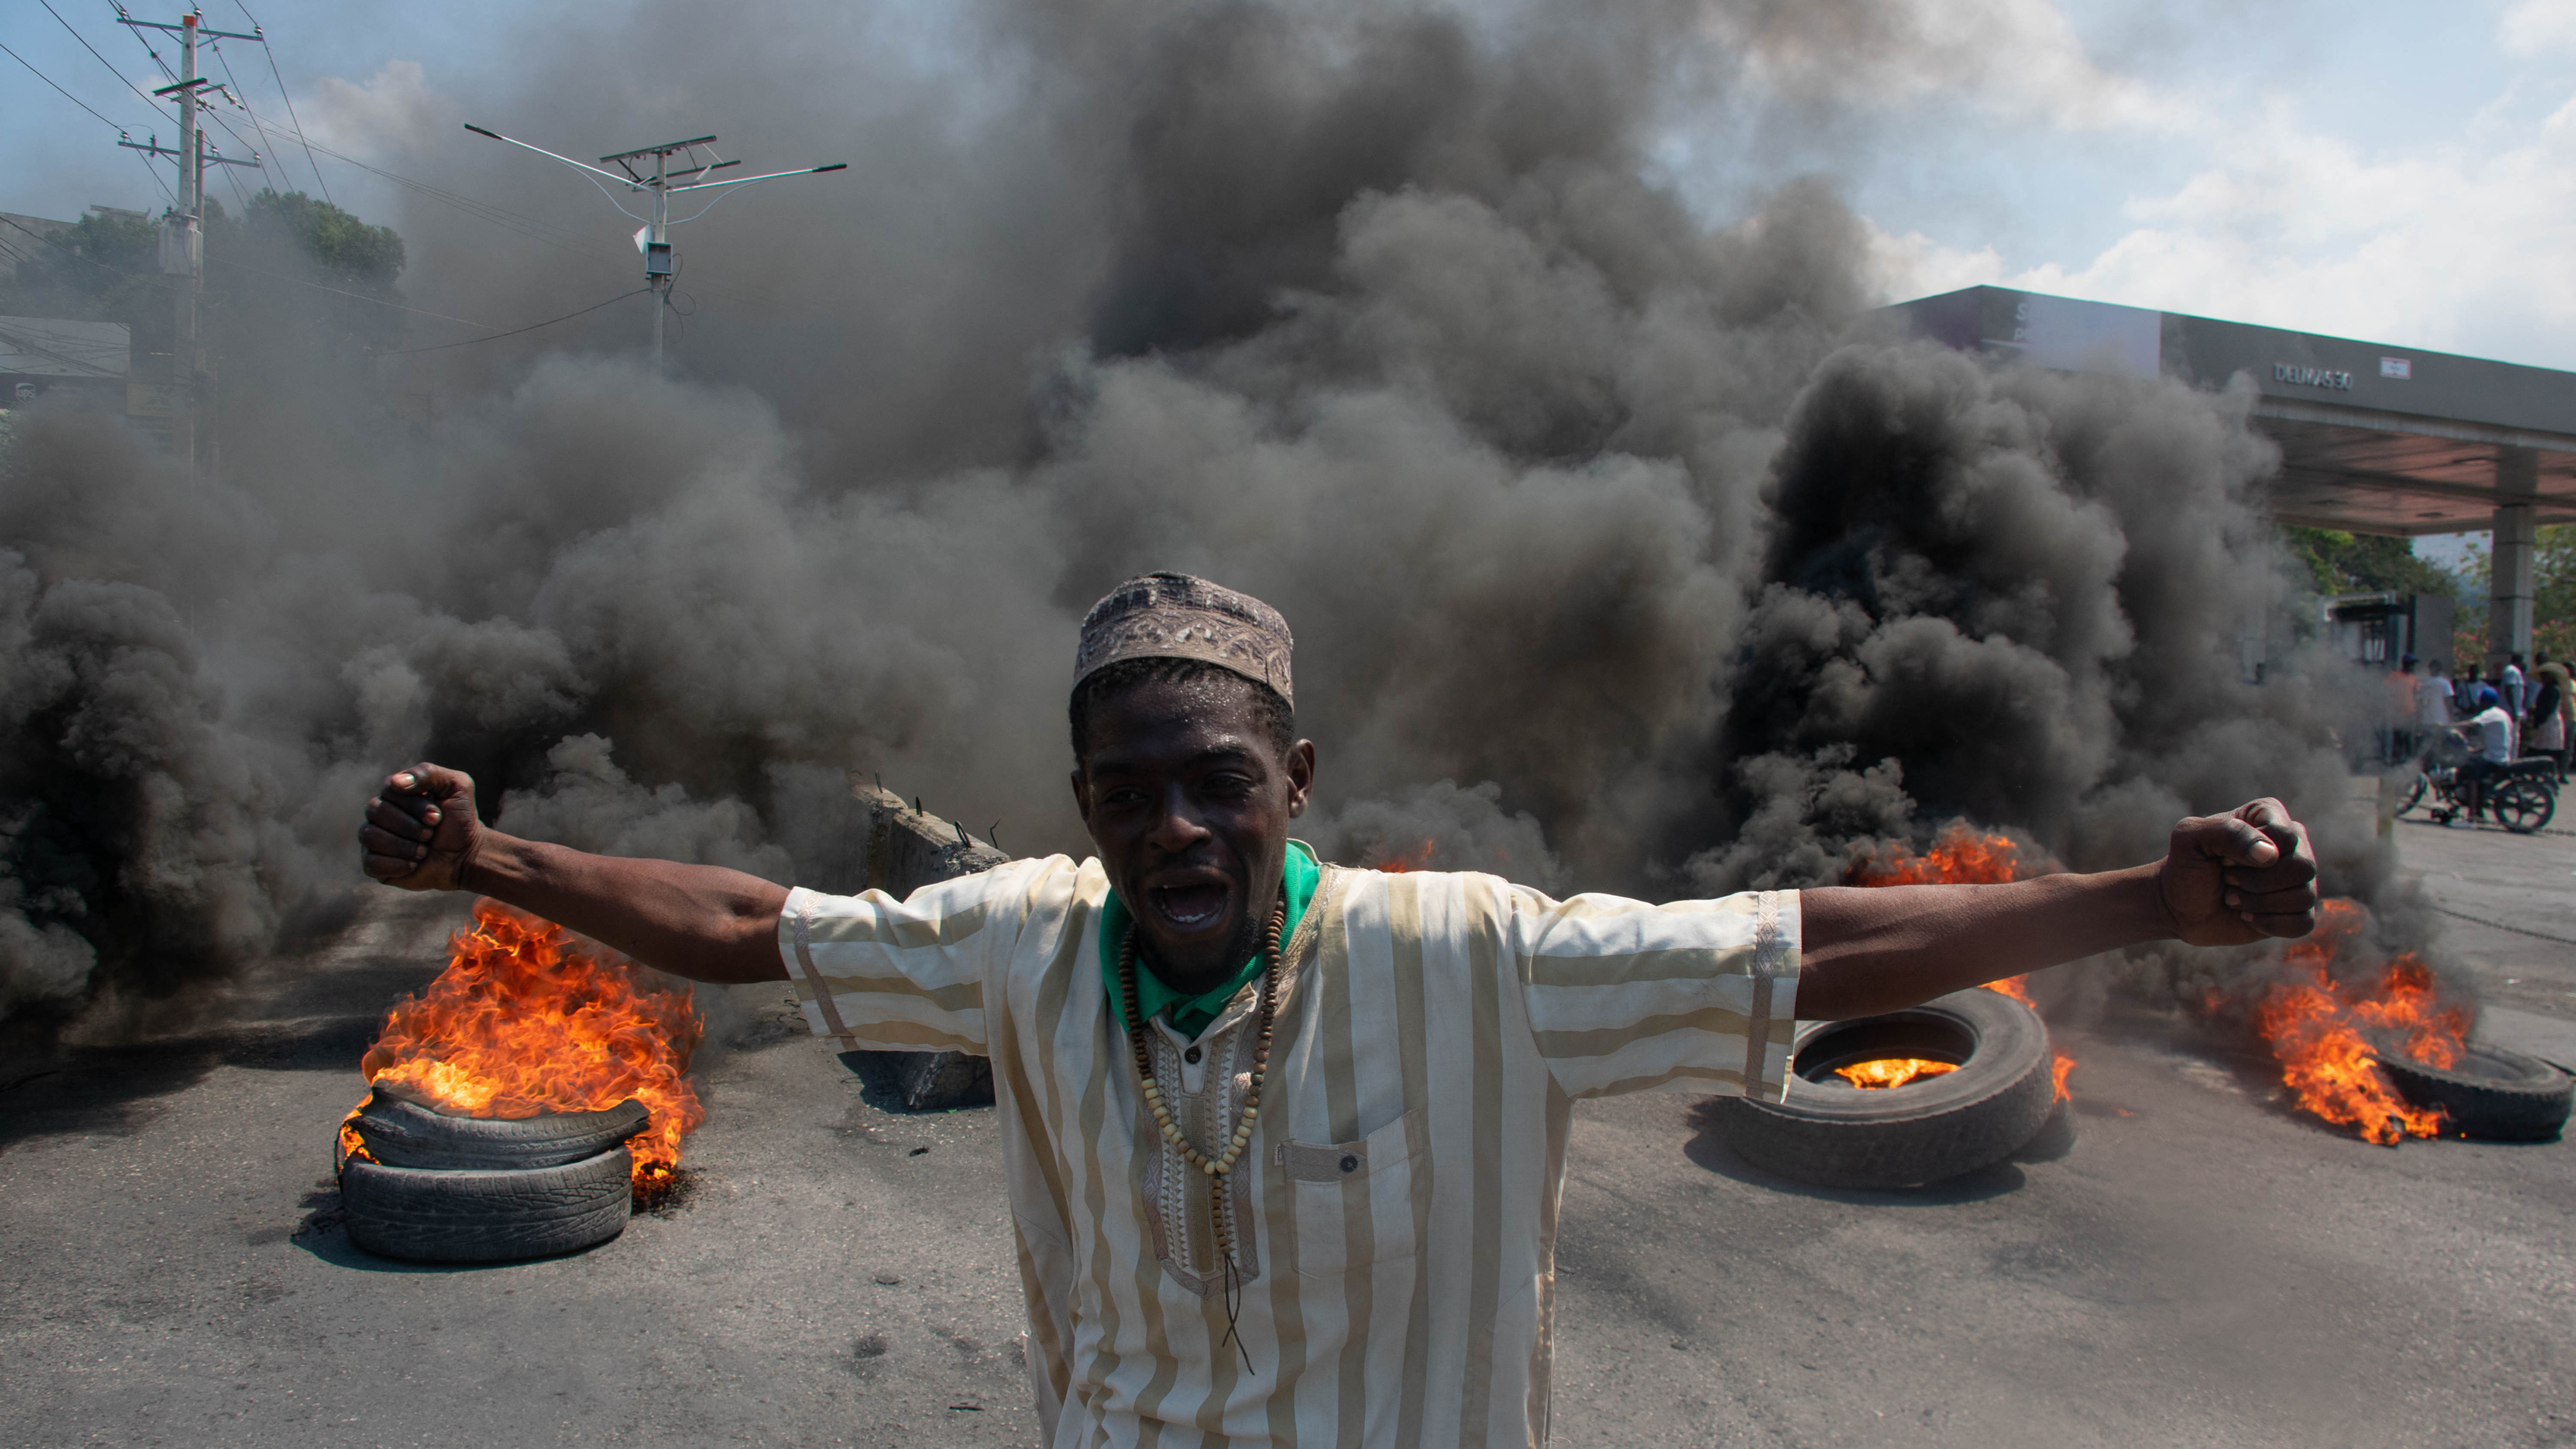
[{"x1": 358, "y1": 764, "x2": 788, "y2": 982}]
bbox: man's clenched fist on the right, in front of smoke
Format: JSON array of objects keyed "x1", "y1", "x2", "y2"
[{"x1": 2156, "y1": 797, "x2": 2319, "y2": 946}]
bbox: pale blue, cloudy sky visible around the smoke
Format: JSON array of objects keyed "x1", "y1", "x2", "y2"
[{"x1": 0, "y1": 0, "x2": 2576, "y2": 402}]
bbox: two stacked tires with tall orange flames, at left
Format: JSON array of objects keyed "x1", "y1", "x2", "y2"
[{"x1": 340, "y1": 900, "x2": 706, "y2": 1263}]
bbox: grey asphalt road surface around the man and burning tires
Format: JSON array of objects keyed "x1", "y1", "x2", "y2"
[{"x1": 0, "y1": 823, "x2": 2576, "y2": 1449}]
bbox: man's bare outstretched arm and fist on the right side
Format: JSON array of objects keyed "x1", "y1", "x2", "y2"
[{"x1": 1798, "y1": 799, "x2": 2319, "y2": 1021}]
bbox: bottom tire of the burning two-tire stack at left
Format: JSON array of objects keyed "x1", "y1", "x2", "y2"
[{"x1": 340, "y1": 1148, "x2": 634, "y2": 1263}]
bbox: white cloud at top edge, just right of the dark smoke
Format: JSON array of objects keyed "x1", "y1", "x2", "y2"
[{"x1": 1705, "y1": 0, "x2": 2195, "y2": 129}]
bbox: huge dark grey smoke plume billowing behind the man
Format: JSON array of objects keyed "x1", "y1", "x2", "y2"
[{"x1": 0, "y1": 0, "x2": 2431, "y2": 1036}]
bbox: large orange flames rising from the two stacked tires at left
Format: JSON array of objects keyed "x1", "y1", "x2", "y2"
[{"x1": 340, "y1": 900, "x2": 706, "y2": 1194}]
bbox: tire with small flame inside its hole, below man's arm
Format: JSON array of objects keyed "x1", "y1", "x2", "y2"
[{"x1": 1711, "y1": 988, "x2": 2056, "y2": 1188}]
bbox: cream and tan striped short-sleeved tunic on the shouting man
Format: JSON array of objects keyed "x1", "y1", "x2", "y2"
[{"x1": 778, "y1": 856, "x2": 1798, "y2": 1449}]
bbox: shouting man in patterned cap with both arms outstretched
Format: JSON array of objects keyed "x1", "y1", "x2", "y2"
[{"x1": 360, "y1": 573, "x2": 2316, "y2": 1447}]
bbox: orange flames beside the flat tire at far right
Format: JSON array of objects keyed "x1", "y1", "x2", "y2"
[{"x1": 2210, "y1": 900, "x2": 2468, "y2": 1148}]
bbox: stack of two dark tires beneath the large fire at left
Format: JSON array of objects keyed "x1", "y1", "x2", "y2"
[{"x1": 340, "y1": 1083, "x2": 649, "y2": 1263}]
